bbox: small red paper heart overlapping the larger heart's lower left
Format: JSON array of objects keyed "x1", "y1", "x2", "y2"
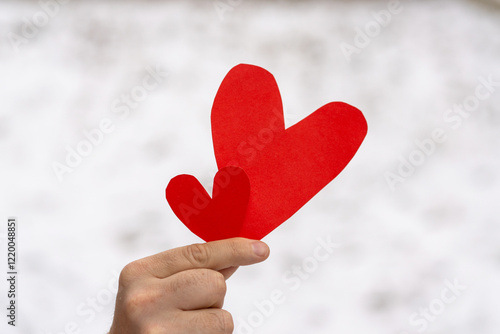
[{"x1": 165, "y1": 166, "x2": 250, "y2": 242}]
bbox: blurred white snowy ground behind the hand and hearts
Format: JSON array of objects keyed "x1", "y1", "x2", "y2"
[{"x1": 0, "y1": 0, "x2": 500, "y2": 334}]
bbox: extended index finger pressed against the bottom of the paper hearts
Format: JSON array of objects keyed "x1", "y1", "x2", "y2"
[{"x1": 141, "y1": 238, "x2": 269, "y2": 278}]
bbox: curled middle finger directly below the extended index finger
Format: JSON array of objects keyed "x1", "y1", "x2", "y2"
[{"x1": 169, "y1": 269, "x2": 227, "y2": 311}]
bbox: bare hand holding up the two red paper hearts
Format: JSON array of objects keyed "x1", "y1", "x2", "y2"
[{"x1": 109, "y1": 238, "x2": 269, "y2": 334}]
